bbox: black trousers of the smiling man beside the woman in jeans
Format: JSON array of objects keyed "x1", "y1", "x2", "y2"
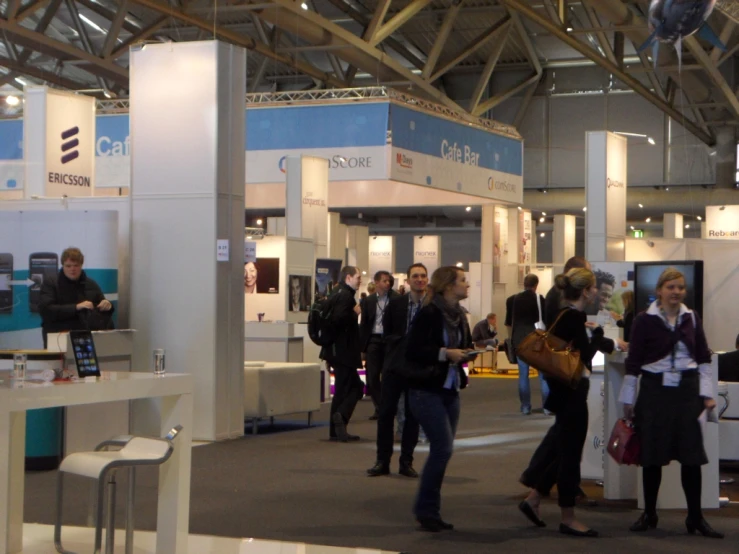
[{"x1": 377, "y1": 371, "x2": 418, "y2": 465}]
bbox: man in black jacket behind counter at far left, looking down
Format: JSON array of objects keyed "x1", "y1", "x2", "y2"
[{"x1": 39, "y1": 248, "x2": 113, "y2": 348}]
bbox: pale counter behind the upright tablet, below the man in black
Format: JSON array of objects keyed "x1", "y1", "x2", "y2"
[{"x1": 47, "y1": 329, "x2": 135, "y2": 455}]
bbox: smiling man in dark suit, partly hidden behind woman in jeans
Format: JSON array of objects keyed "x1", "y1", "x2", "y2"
[{"x1": 367, "y1": 264, "x2": 429, "y2": 478}]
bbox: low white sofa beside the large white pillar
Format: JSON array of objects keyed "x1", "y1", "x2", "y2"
[{"x1": 244, "y1": 362, "x2": 321, "y2": 435}]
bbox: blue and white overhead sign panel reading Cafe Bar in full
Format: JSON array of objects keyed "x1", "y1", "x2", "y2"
[{"x1": 390, "y1": 104, "x2": 523, "y2": 204}]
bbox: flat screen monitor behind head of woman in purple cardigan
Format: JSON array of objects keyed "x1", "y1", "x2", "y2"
[{"x1": 634, "y1": 260, "x2": 703, "y2": 318}]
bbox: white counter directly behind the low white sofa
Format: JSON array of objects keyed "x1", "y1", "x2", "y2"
[{"x1": 244, "y1": 321, "x2": 303, "y2": 363}]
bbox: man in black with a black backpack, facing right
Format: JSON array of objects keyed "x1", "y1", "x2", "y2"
[{"x1": 321, "y1": 266, "x2": 364, "y2": 442}]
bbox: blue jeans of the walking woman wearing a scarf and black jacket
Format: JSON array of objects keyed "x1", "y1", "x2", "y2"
[{"x1": 408, "y1": 389, "x2": 459, "y2": 519}]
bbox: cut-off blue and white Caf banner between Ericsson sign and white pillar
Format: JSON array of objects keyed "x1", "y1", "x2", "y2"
[{"x1": 95, "y1": 114, "x2": 131, "y2": 188}]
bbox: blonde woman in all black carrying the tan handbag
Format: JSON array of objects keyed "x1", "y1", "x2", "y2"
[{"x1": 519, "y1": 268, "x2": 623, "y2": 537}]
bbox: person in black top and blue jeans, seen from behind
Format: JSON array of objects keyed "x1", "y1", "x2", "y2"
[{"x1": 511, "y1": 273, "x2": 549, "y2": 415}]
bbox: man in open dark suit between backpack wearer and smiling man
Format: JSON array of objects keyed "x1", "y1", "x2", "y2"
[{"x1": 359, "y1": 271, "x2": 395, "y2": 420}]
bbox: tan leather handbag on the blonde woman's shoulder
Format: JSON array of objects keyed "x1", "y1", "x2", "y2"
[{"x1": 516, "y1": 311, "x2": 582, "y2": 389}]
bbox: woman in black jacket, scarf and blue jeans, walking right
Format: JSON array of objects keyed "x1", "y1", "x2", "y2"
[{"x1": 406, "y1": 266, "x2": 472, "y2": 532}]
